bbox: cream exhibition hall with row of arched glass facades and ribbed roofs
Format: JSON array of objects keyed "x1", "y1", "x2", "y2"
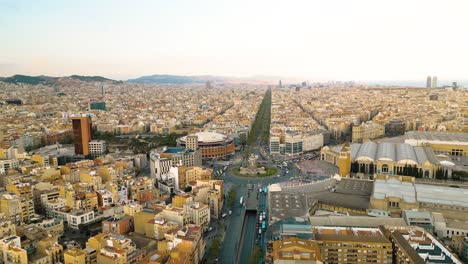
[{"x1": 321, "y1": 141, "x2": 444, "y2": 178}]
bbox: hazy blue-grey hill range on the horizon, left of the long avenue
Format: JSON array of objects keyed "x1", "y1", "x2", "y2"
[{"x1": 127, "y1": 74, "x2": 225, "y2": 84}]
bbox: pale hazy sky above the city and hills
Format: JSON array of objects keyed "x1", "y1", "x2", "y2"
[{"x1": 0, "y1": 0, "x2": 468, "y2": 80}]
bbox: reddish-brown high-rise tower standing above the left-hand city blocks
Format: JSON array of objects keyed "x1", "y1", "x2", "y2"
[{"x1": 72, "y1": 116, "x2": 92, "y2": 156}]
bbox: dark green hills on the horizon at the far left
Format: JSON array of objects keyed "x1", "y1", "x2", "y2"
[{"x1": 0, "y1": 74, "x2": 121, "y2": 85}]
